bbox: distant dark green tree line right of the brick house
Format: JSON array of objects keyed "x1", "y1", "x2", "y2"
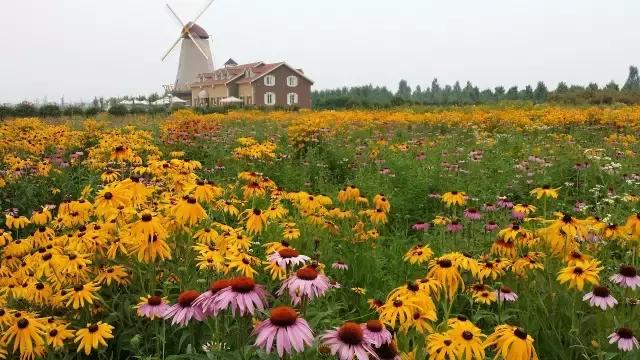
[{"x1": 312, "y1": 66, "x2": 640, "y2": 109}]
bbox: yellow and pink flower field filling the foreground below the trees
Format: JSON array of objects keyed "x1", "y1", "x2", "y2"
[{"x1": 0, "y1": 105, "x2": 640, "y2": 360}]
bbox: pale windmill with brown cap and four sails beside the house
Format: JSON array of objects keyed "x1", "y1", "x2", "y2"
[{"x1": 162, "y1": 0, "x2": 214, "y2": 100}]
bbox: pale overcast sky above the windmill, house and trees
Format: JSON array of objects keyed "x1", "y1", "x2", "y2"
[{"x1": 0, "y1": 0, "x2": 640, "y2": 103}]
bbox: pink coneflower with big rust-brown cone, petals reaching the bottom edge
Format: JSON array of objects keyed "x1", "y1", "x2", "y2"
[{"x1": 322, "y1": 322, "x2": 377, "y2": 360}]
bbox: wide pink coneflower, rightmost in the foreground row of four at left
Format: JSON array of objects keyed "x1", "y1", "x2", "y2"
[{"x1": 213, "y1": 277, "x2": 268, "y2": 316}]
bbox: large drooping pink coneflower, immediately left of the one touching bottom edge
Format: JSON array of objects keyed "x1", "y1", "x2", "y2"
[{"x1": 252, "y1": 306, "x2": 313, "y2": 358}]
